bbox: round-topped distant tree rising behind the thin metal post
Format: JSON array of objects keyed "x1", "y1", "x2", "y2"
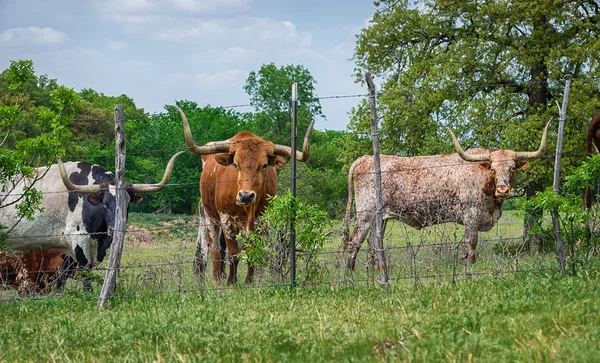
[{"x1": 244, "y1": 63, "x2": 324, "y2": 145}]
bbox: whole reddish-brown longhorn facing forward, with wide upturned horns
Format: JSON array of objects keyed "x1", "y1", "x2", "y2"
[{"x1": 174, "y1": 106, "x2": 313, "y2": 285}]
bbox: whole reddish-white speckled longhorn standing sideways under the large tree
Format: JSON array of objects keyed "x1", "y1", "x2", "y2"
[{"x1": 342, "y1": 123, "x2": 549, "y2": 269}]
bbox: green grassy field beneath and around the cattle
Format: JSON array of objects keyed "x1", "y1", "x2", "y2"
[{"x1": 0, "y1": 212, "x2": 600, "y2": 362}]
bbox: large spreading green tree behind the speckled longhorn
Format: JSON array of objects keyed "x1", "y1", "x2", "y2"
[{"x1": 351, "y1": 0, "x2": 600, "y2": 240}]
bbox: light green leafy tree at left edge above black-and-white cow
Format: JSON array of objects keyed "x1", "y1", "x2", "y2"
[{"x1": 0, "y1": 60, "x2": 77, "y2": 248}]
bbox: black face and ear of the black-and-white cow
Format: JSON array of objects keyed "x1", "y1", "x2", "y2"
[{"x1": 87, "y1": 183, "x2": 146, "y2": 262}]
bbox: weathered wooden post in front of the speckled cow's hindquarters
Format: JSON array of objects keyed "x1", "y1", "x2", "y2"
[{"x1": 365, "y1": 72, "x2": 389, "y2": 284}]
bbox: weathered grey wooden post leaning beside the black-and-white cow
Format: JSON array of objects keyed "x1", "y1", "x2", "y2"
[{"x1": 98, "y1": 105, "x2": 129, "y2": 308}]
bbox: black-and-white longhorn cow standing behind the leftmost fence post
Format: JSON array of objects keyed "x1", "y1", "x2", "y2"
[{"x1": 0, "y1": 152, "x2": 183, "y2": 288}]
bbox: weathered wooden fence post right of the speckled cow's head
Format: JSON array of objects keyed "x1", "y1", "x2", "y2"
[{"x1": 552, "y1": 77, "x2": 571, "y2": 273}]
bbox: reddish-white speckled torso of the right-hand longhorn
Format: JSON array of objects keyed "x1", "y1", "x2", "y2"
[{"x1": 353, "y1": 149, "x2": 493, "y2": 228}]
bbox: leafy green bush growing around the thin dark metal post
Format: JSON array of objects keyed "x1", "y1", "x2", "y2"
[{"x1": 238, "y1": 191, "x2": 329, "y2": 284}]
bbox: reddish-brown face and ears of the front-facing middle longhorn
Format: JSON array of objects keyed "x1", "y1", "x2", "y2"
[{"x1": 215, "y1": 140, "x2": 286, "y2": 207}]
